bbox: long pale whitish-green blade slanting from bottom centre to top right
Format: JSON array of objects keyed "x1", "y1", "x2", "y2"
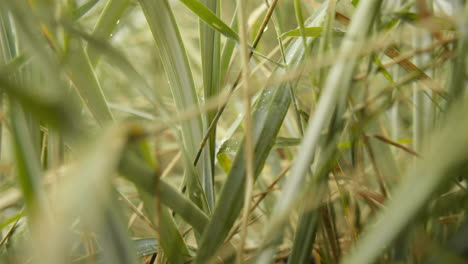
[{"x1": 258, "y1": 0, "x2": 381, "y2": 263}]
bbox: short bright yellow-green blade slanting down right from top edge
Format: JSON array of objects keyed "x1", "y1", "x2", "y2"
[{"x1": 180, "y1": 0, "x2": 239, "y2": 41}]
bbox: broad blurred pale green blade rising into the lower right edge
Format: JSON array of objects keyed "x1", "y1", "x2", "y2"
[{"x1": 343, "y1": 104, "x2": 468, "y2": 264}]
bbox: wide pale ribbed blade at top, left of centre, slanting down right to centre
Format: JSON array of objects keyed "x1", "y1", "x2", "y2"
[{"x1": 140, "y1": 0, "x2": 211, "y2": 211}]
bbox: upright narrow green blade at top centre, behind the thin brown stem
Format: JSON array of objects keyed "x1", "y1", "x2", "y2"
[{"x1": 200, "y1": 0, "x2": 221, "y2": 211}]
